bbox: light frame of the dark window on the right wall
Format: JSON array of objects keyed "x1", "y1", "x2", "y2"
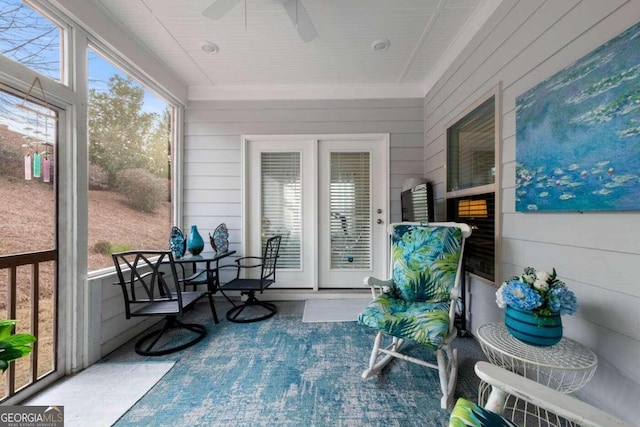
[{"x1": 444, "y1": 83, "x2": 502, "y2": 287}]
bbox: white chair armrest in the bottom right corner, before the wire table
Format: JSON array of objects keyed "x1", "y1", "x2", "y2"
[{"x1": 475, "y1": 362, "x2": 632, "y2": 427}]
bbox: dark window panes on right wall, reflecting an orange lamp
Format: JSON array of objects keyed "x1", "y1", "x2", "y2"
[{"x1": 447, "y1": 96, "x2": 496, "y2": 281}]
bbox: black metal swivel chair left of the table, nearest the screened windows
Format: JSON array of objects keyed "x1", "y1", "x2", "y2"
[{"x1": 112, "y1": 250, "x2": 218, "y2": 356}]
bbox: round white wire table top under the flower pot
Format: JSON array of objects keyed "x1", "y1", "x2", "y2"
[{"x1": 476, "y1": 323, "x2": 598, "y2": 370}]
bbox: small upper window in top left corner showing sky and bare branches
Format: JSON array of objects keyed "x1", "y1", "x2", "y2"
[{"x1": 0, "y1": 0, "x2": 63, "y2": 81}]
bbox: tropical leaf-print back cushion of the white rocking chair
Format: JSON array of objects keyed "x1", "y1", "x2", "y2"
[{"x1": 389, "y1": 223, "x2": 471, "y2": 302}]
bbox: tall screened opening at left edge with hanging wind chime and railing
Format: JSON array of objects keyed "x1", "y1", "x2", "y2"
[{"x1": 0, "y1": 91, "x2": 57, "y2": 400}]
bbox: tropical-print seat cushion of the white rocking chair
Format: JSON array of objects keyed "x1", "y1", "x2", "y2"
[{"x1": 358, "y1": 293, "x2": 449, "y2": 350}]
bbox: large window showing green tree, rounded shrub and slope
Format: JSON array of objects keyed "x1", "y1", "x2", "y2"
[{"x1": 88, "y1": 50, "x2": 174, "y2": 271}]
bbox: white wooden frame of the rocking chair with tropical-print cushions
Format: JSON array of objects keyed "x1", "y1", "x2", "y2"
[{"x1": 362, "y1": 222, "x2": 471, "y2": 409}]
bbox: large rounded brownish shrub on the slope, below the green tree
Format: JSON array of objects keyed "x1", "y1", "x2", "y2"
[{"x1": 116, "y1": 169, "x2": 167, "y2": 212}]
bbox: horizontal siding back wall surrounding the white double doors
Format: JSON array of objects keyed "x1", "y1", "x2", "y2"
[{"x1": 183, "y1": 98, "x2": 424, "y2": 266}]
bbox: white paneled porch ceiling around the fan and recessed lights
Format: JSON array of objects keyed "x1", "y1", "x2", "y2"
[{"x1": 92, "y1": 0, "x2": 488, "y2": 95}]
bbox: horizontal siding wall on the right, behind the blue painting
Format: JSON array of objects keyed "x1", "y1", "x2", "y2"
[{"x1": 424, "y1": 0, "x2": 640, "y2": 422}]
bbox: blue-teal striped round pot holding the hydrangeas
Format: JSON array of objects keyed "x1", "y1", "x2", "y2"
[{"x1": 504, "y1": 306, "x2": 562, "y2": 346}]
